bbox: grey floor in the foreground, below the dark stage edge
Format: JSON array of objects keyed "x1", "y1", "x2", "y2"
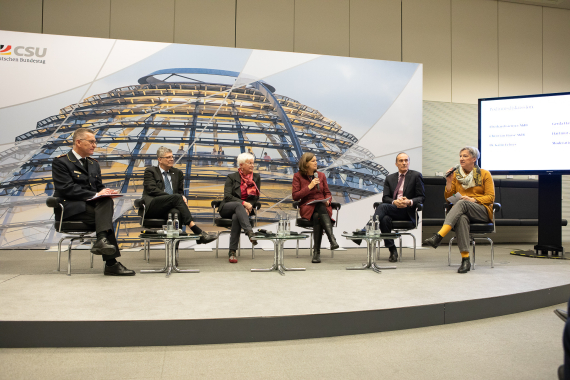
[{"x1": 0, "y1": 304, "x2": 566, "y2": 380}]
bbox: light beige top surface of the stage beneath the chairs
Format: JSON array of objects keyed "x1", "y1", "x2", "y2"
[{"x1": 0, "y1": 245, "x2": 570, "y2": 321}]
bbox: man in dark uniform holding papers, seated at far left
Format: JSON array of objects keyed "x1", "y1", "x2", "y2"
[{"x1": 52, "y1": 128, "x2": 135, "y2": 276}]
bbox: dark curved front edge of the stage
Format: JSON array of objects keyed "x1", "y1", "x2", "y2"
[{"x1": 0, "y1": 284, "x2": 570, "y2": 348}]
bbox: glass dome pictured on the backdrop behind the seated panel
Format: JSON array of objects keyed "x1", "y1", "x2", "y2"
[{"x1": 0, "y1": 68, "x2": 388, "y2": 247}]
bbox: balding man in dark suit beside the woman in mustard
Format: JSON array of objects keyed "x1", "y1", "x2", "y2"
[{"x1": 354, "y1": 152, "x2": 425, "y2": 262}]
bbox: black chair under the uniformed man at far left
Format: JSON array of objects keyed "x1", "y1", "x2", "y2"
[{"x1": 46, "y1": 197, "x2": 97, "y2": 276}]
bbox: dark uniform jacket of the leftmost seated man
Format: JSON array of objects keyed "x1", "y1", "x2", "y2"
[{"x1": 51, "y1": 150, "x2": 105, "y2": 219}]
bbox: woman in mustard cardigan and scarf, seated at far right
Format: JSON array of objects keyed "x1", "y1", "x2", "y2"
[{"x1": 425, "y1": 146, "x2": 495, "y2": 273}]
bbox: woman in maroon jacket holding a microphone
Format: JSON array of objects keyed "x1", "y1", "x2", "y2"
[{"x1": 292, "y1": 153, "x2": 338, "y2": 263}]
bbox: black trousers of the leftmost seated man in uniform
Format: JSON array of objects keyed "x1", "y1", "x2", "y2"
[{"x1": 63, "y1": 198, "x2": 121, "y2": 261}]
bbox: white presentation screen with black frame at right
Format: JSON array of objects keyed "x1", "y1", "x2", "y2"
[{"x1": 479, "y1": 93, "x2": 570, "y2": 174}]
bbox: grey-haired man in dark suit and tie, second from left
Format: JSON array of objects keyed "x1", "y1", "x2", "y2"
[{"x1": 139, "y1": 146, "x2": 217, "y2": 244}]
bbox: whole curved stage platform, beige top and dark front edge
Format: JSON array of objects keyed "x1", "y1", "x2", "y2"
[{"x1": 0, "y1": 244, "x2": 570, "y2": 347}]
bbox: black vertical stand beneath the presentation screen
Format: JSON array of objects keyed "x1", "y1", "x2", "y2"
[{"x1": 536, "y1": 174, "x2": 564, "y2": 256}]
